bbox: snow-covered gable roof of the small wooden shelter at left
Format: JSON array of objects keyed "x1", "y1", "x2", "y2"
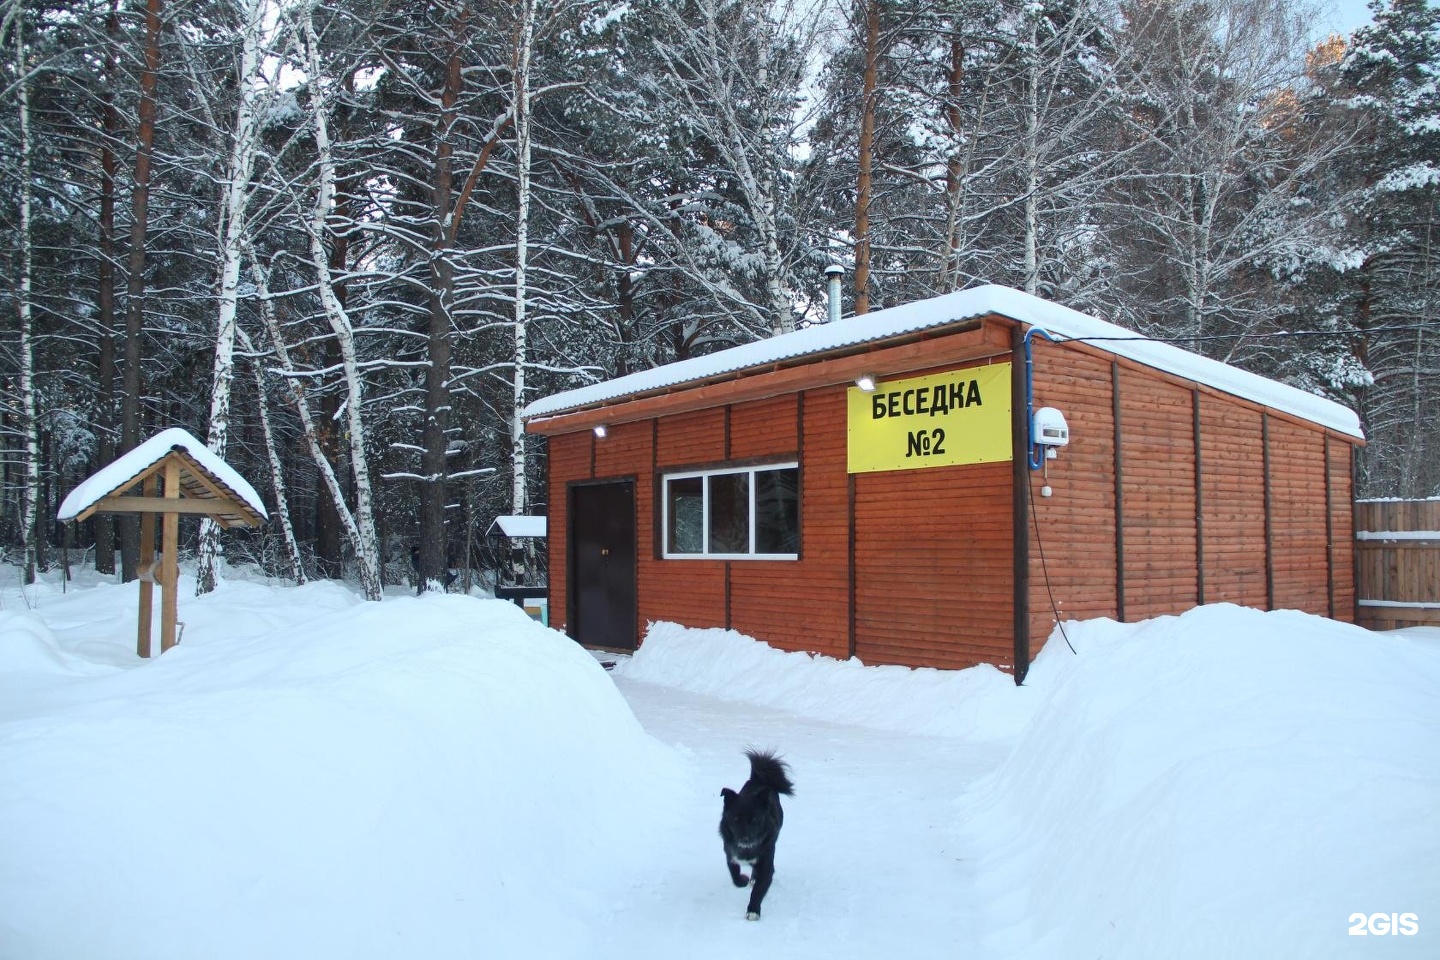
[{"x1": 58, "y1": 427, "x2": 269, "y2": 525}]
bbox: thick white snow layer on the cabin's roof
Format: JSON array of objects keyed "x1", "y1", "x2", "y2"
[{"x1": 521, "y1": 284, "x2": 1365, "y2": 439}]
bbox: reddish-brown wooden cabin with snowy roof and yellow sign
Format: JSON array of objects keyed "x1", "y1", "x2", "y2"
[{"x1": 524, "y1": 286, "x2": 1364, "y2": 682}]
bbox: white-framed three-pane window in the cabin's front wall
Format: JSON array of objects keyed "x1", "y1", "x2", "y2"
[{"x1": 661, "y1": 463, "x2": 801, "y2": 560}]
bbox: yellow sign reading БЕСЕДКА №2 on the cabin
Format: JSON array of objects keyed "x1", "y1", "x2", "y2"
[{"x1": 847, "y1": 363, "x2": 1012, "y2": 474}]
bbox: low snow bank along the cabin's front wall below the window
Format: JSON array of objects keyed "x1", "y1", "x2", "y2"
[{"x1": 615, "y1": 622, "x2": 1038, "y2": 740}]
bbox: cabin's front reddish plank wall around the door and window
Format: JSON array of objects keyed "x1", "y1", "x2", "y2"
[{"x1": 550, "y1": 359, "x2": 1014, "y2": 668}]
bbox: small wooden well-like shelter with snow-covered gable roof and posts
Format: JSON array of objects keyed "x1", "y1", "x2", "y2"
[{"x1": 59, "y1": 429, "x2": 265, "y2": 656}]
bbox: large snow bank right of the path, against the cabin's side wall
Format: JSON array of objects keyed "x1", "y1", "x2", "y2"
[{"x1": 958, "y1": 604, "x2": 1440, "y2": 959}]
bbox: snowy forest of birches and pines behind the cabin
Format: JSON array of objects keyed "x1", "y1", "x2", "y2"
[{"x1": 0, "y1": 0, "x2": 1440, "y2": 597}]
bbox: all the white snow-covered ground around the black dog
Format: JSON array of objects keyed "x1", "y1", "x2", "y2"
[{"x1": 0, "y1": 569, "x2": 1440, "y2": 960}]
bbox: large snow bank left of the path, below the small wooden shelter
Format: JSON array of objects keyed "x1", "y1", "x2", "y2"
[{"x1": 0, "y1": 583, "x2": 680, "y2": 960}]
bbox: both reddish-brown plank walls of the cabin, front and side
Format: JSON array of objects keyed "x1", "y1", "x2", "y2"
[{"x1": 550, "y1": 326, "x2": 1353, "y2": 668}]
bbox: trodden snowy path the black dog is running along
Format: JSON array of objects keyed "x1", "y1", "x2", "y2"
[{"x1": 596, "y1": 676, "x2": 999, "y2": 959}]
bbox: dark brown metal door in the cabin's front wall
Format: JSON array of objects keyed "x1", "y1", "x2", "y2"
[{"x1": 570, "y1": 481, "x2": 636, "y2": 651}]
